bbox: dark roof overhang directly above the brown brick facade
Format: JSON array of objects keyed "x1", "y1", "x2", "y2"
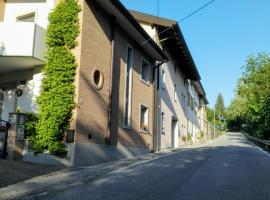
[{"x1": 96, "y1": 0, "x2": 167, "y2": 61}]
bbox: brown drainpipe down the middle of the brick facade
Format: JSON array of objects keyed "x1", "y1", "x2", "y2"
[{"x1": 105, "y1": 16, "x2": 116, "y2": 145}]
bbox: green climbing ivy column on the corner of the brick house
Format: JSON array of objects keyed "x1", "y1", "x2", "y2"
[{"x1": 32, "y1": 0, "x2": 81, "y2": 156}]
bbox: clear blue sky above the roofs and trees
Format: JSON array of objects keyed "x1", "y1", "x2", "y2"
[{"x1": 121, "y1": 0, "x2": 270, "y2": 107}]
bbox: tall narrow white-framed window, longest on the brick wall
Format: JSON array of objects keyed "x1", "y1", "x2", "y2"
[{"x1": 123, "y1": 44, "x2": 134, "y2": 129}]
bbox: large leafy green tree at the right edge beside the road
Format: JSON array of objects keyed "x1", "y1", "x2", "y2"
[{"x1": 227, "y1": 53, "x2": 270, "y2": 139}]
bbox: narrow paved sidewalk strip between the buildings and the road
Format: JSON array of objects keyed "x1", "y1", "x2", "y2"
[{"x1": 0, "y1": 138, "x2": 221, "y2": 200}]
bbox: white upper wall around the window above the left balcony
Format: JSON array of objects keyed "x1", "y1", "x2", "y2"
[{"x1": 4, "y1": 0, "x2": 54, "y2": 28}]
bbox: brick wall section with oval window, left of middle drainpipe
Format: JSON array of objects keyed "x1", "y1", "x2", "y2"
[{"x1": 75, "y1": 2, "x2": 111, "y2": 144}]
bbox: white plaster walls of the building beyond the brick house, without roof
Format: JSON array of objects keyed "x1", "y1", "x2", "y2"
[{"x1": 141, "y1": 23, "x2": 200, "y2": 149}]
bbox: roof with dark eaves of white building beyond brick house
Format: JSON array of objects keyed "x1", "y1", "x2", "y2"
[{"x1": 130, "y1": 10, "x2": 201, "y2": 81}]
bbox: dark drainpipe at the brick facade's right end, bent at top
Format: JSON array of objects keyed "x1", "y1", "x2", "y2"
[{"x1": 152, "y1": 60, "x2": 167, "y2": 152}]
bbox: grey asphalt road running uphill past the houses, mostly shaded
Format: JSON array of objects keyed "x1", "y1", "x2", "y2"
[{"x1": 44, "y1": 133, "x2": 270, "y2": 200}]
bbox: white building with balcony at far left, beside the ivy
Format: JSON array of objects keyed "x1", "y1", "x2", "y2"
[{"x1": 0, "y1": 0, "x2": 55, "y2": 120}]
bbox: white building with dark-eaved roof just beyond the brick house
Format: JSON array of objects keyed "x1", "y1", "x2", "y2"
[{"x1": 130, "y1": 11, "x2": 207, "y2": 150}]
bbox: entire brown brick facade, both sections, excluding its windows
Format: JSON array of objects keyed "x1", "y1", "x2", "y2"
[{"x1": 73, "y1": 0, "x2": 154, "y2": 149}]
